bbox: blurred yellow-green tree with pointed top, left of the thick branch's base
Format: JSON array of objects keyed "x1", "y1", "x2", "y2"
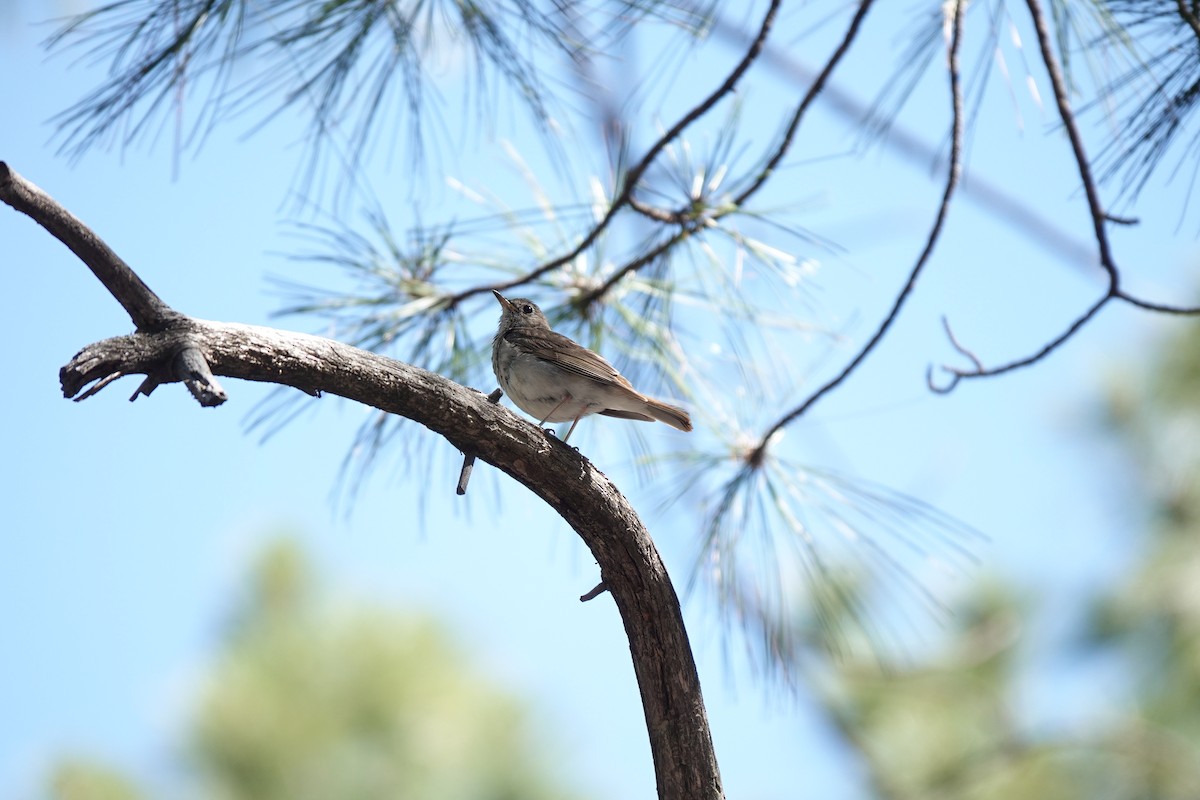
[{"x1": 52, "y1": 540, "x2": 590, "y2": 800}]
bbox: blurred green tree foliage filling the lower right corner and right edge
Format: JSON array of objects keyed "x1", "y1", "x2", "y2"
[{"x1": 821, "y1": 314, "x2": 1200, "y2": 800}]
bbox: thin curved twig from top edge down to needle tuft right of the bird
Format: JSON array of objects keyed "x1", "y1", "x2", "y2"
[{"x1": 746, "y1": 0, "x2": 964, "y2": 463}]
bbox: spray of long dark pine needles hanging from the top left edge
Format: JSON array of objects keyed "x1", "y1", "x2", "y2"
[{"x1": 49, "y1": 0, "x2": 696, "y2": 179}]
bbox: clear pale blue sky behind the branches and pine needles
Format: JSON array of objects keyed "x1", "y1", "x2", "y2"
[{"x1": 0, "y1": 2, "x2": 1196, "y2": 800}]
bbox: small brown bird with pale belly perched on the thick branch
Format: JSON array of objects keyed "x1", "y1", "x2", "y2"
[{"x1": 492, "y1": 289, "x2": 691, "y2": 443}]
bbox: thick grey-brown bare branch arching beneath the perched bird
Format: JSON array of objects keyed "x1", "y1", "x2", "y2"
[{"x1": 11, "y1": 168, "x2": 724, "y2": 800}]
